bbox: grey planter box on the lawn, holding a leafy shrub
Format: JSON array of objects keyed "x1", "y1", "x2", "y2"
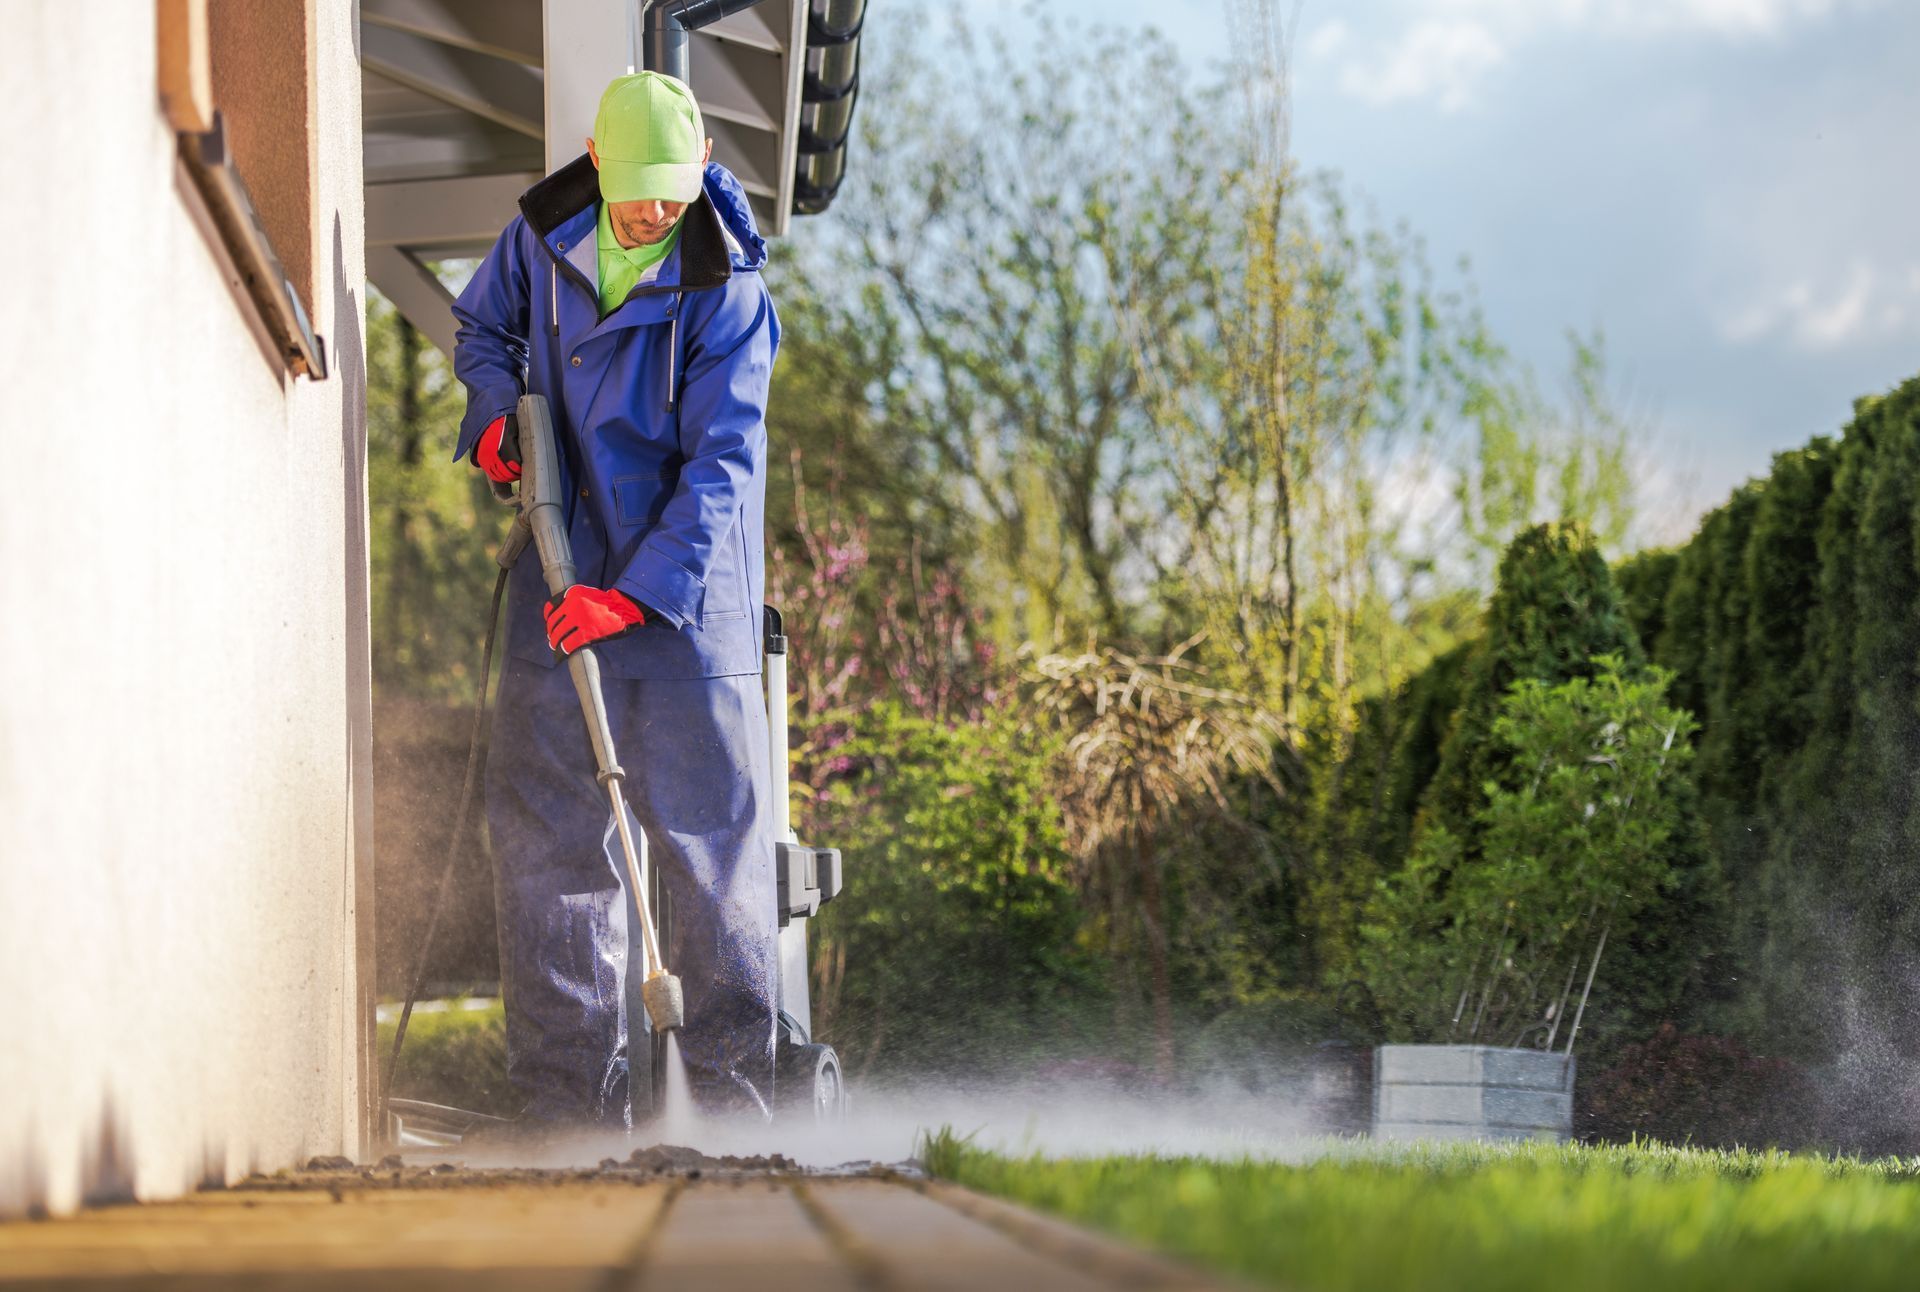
[{"x1": 1373, "y1": 1044, "x2": 1574, "y2": 1142}]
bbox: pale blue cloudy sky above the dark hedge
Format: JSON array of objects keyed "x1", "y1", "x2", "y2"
[{"x1": 944, "y1": 0, "x2": 1920, "y2": 538}]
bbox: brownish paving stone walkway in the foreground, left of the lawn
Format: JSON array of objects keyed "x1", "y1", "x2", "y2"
[{"x1": 0, "y1": 1169, "x2": 1221, "y2": 1292}]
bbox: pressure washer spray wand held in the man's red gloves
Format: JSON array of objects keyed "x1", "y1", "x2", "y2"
[{"x1": 495, "y1": 395, "x2": 687, "y2": 1031}]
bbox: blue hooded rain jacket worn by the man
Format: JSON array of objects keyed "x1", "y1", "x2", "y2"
[{"x1": 453, "y1": 156, "x2": 780, "y2": 680}]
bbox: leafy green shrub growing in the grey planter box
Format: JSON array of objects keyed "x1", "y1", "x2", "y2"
[{"x1": 1361, "y1": 657, "x2": 1693, "y2": 1048}]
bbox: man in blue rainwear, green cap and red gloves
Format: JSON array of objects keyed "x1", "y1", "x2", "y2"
[{"x1": 453, "y1": 73, "x2": 780, "y2": 1127}]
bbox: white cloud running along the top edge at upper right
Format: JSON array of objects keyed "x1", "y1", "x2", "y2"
[{"x1": 1300, "y1": 0, "x2": 1887, "y2": 111}]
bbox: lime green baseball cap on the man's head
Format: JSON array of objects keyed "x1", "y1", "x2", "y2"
[{"x1": 593, "y1": 71, "x2": 707, "y2": 202}]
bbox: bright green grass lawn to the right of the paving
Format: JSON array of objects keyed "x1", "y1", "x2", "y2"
[{"x1": 922, "y1": 1131, "x2": 1920, "y2": 1292}]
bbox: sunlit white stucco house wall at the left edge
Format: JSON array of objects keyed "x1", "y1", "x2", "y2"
[{"x1": 0, "y1": 0, "x2": 369, "y2": 1213}]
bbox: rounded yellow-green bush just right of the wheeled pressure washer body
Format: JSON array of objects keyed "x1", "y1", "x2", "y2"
[{"x1": 810, "y1": 703, "x2": 1100, "y2": 1073}]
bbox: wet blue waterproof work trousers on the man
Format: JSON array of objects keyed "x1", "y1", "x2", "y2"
[{"x1": 488, "y1": 648, "x2": 778, "y2": 1127}]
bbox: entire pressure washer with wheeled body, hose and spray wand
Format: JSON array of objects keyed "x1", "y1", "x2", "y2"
[{"x1": 382, "y1": 395, "x2": 849, "y2": 1148}]
